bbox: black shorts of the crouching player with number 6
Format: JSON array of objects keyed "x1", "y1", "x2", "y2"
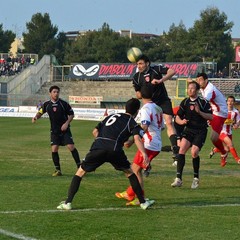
[{"x1": 81, "y1": 149, "x2": 130, "y2": 172}]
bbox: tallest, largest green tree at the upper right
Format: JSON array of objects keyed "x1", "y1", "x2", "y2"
[{"x1": 189, "y1": 7, "x2": 234, "y2": 70}]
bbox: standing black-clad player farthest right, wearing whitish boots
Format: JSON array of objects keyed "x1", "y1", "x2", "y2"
[{"x1": 171, "y1": 82, "x2": 212, "y2": 189}]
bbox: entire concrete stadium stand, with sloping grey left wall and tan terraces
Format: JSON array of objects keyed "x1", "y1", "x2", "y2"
[{"x1": 0, "y1": 55, "x2": 240, "y2": 109}]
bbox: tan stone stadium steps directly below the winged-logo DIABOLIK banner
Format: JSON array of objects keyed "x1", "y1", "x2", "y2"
[{"x1": 37, "y1": 80, "x2": 176, "y2": 109}]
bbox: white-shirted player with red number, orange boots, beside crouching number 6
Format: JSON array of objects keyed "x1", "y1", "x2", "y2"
[{"x1": 115, "y1": 85, "x2": 164, "y2": 205}]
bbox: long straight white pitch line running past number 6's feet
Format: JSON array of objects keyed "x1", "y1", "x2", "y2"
[{"x1": 0, "y1": 203, "x2": 240, "y2": 214}]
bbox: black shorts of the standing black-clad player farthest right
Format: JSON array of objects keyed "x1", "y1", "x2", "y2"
[{"x1": 182, "y1": 127, "x2": 207, "y2": 149}]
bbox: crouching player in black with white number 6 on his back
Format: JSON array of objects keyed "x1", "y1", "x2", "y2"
[{"x1": 57, "y1": 98, "x2": 154, "y2": 210}]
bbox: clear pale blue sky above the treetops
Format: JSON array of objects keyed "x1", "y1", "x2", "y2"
[{"x1": 0, "y1": 0, "x2": 240, "y2": 38}]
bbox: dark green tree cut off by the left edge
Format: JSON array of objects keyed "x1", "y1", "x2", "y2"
[{"x1": 0, "y1": 24, "x2": 16, "y2": 53}]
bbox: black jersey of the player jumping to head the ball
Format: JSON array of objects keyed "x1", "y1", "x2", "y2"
[{"x1": 133, "y1": 65, "x2": 169, "y2": 106}]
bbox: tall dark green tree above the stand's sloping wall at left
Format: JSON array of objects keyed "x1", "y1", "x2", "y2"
[{"x1": 23, "y1": 13, "x2": 58, "y2": 58}]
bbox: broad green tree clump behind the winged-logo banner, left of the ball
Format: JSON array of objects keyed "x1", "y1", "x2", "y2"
[{"x1": 64, "y1": 23, "x2": 130, "y2": 64}]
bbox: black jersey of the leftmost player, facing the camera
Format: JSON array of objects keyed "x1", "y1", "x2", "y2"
[{"x1": 39, "y1": 98, "x2": 74, "y2": 134}]
